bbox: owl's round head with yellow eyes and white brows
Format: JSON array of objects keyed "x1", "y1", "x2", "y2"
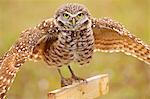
[{"x1": 54, "y1": 3, "x2": 91, "y2": 30}]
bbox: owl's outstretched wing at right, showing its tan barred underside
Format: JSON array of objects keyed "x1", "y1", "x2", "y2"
[{"x1": 92, "y1": 18, "x2": 150, "y2": 64}]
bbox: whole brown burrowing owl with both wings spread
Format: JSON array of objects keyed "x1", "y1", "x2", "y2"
[{"x1": 0, "y1": 4, "x2": 150, "y2": 99}]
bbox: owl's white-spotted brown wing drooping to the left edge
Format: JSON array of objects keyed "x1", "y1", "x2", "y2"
[{"x1": 0, "y1": 19, "x2": 58, "y2": 99}]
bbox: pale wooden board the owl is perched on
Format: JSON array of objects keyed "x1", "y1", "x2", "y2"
[{"x1": 48, "y1": 74, "x2": 109, "y2": 99}]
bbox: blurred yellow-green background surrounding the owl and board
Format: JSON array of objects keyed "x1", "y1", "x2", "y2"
[{"x1": 0, "y1": 0, "x2": 150, "y2": 99}]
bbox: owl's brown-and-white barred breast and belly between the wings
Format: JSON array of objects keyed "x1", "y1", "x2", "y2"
[{"x1": 44, "y1": 31, "x2": 94, "y2": 66}]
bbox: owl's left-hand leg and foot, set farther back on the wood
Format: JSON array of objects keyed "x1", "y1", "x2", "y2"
[{"x1": 57, "y1": 68, "x2": 72, "y2": 87}]
